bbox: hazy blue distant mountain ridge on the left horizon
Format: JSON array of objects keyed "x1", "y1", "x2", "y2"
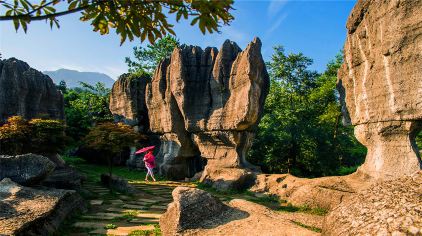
[{"x1": 43, "y1": 69, "x2": 114, "y2": 88}]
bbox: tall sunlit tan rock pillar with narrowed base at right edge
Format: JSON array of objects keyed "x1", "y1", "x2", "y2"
[{"x1": 338, "y1": 0, "x2": 422, "y2": 179}]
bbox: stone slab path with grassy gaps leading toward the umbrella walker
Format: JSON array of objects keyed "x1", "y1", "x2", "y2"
[{"x1": 67, "y1": 181, "x2": 193, "y2": 236}]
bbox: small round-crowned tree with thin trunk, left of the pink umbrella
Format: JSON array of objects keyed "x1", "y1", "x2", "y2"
[{"x1": 84, "y1": 122, "x2": 140, "y2": 177}]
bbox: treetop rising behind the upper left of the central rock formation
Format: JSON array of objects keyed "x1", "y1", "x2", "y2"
[{"x1": 125, "y1": 36, "x2": 180, "y2": 75}]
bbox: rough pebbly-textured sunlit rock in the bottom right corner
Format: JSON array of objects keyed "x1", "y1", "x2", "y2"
[{"x1": 323, "y1": 172, "x2": 422, "y2": 235}]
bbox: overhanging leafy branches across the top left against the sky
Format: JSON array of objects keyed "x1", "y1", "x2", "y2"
[{"x1": 0, "y1": 0, "x2": 233, "y2": 44}]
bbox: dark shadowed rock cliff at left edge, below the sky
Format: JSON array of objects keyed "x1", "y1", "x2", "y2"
[{"x1": 0, "y1": 58, "x2": 64, "y2": 122}]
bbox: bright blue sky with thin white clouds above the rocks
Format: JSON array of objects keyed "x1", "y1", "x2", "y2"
[{"x1": 0, "y1": 0, "x2": 356, "y2": 79}]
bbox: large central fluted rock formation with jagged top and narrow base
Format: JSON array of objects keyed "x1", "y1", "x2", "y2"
[{"x1": 146, "y1": 38, "x2": 269, "y2": 189}]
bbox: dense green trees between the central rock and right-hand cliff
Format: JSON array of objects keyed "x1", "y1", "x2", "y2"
[{"x1": 249, "y1": 47, "x2": 364, "y2": 177}]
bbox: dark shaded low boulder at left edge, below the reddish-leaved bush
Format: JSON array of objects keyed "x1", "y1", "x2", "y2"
[{"x1": 0, "y1": 154, "x2": 56, "y2": 185}]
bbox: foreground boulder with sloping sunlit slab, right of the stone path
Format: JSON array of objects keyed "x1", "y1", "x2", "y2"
[{"x1": 160, "y1": 187, "x2": 319, "y2": 236}]
